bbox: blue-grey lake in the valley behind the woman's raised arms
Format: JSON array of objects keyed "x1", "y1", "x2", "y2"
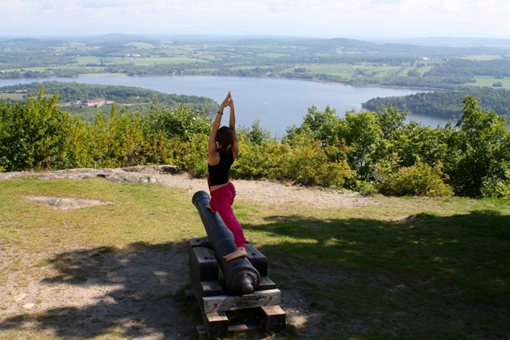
[{"x1": 0, "y1": 75, "x2": 446, "y2": 137}]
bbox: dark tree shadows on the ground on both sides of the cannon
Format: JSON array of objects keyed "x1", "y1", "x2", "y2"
[{"x1": 0, "y1": 211, "x2": 510, "y2": 338}]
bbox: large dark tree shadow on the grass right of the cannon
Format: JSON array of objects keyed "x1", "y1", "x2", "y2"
[{"x1": 245, "y1": 211, "x2": 510, "y2": 338}]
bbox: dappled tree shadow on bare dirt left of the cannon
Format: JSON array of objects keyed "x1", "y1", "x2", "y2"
[{"x1": 0, "y1": 242, "x2": 194, "y2": 338}]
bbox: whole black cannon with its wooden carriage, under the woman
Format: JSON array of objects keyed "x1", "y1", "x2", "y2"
[{"x1": 189, "y1": 191, "x2": 286, "y2": 338}]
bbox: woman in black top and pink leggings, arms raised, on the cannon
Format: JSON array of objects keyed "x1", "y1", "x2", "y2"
[{"x1": 207, "y1": 91, "x2": 246, "y2": 261}]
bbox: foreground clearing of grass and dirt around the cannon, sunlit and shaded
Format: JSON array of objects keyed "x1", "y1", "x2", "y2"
[{"x1": 0, "y1": 175, "x2": 510, "y2": 339}]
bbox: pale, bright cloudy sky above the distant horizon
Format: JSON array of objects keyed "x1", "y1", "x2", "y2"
[{"x1": 0, "y1": 0, "x2": 510, "y2": 38}]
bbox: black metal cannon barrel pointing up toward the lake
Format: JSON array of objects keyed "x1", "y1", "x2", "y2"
[{"x1": 192, "y1": 191, "x2": 260, "y2": 295}]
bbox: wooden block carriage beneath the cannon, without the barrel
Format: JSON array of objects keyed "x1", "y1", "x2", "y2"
[{"x1": 188, "y1": 238, "x2": 286, "y2": 339}]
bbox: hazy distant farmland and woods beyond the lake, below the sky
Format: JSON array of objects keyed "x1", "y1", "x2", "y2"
[{"x1": 0, "y1": 35, "x2": 510, "y2": 90}]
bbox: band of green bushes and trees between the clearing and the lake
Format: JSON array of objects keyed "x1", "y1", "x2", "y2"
[{"x1": 0, "y1": 91, "x2": 510, "y2": 198}]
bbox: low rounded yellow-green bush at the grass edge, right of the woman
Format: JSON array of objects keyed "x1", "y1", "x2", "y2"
[{"x1": 379, "y1": 163, "x2": 453, "y2": 196}]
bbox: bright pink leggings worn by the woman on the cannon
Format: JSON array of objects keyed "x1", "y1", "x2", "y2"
[{"x1": 210, "y1": 182, "x2": 246, "y2": 247}]
